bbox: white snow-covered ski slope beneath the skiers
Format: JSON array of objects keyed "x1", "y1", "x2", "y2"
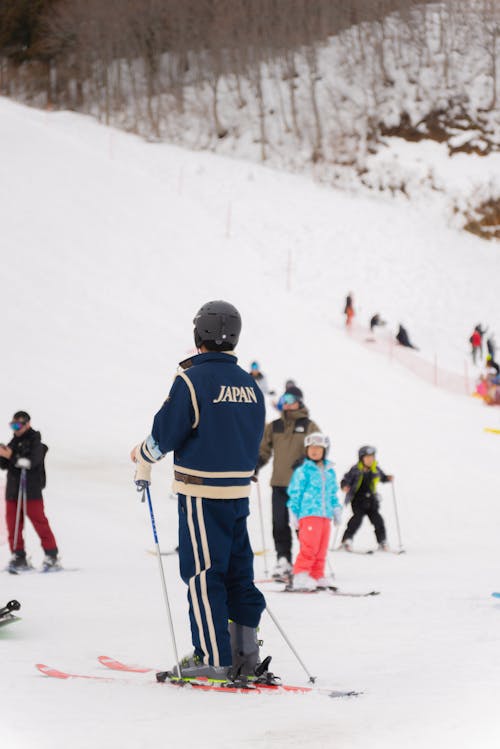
[{"x1": 0, "y1": 100, "x2": 500, "y2": 749}]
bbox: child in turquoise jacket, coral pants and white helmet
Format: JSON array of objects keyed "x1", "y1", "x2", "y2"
[{"x1": 287, "y1": 432, "x2": 342, "y2": 590}]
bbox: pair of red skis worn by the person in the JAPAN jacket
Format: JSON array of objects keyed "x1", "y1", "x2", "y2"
[{"x1": 36, "y1": 656, "x2": 361, "y2": 697}]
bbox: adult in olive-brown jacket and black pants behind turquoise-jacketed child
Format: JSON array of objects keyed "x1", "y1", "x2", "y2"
[{"x1": 257, "y1": 385, "x2": 320, "y2": 578}]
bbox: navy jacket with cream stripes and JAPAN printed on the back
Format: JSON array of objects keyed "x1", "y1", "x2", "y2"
[{"x1": 141, "y1": 352, "x2": 265, "y2": 499}]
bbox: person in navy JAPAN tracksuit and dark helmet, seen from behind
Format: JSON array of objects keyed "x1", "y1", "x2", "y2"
[{"x1": 132, "y1": 301, "x2": 266, "y2": 678}]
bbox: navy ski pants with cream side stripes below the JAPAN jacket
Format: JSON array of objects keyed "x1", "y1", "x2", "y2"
[{"x1": 178, "y1": 494, "x2": 266, "y2": 666}]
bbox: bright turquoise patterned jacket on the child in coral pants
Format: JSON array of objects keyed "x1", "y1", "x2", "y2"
[{"x1": 287, "y1": 458, "x2": 341, "y2": 520}]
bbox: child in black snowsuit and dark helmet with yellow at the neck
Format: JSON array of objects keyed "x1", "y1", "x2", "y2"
[{"x1": 340, "y1": 445, "x2": 393, "y2": 551}]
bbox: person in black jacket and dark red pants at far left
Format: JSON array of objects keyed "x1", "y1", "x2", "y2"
[{"x1": 0, "y1": 411, "x2": 60, "y2": 574}]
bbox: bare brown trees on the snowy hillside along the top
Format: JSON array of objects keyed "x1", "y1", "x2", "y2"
[{"x1": 0, "y1": 0, "x2": 500, "y2": 163}]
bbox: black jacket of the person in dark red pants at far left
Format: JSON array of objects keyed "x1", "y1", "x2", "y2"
[{"x1": 0, "y1": 428, "x2": 47, "y2": 500}]
